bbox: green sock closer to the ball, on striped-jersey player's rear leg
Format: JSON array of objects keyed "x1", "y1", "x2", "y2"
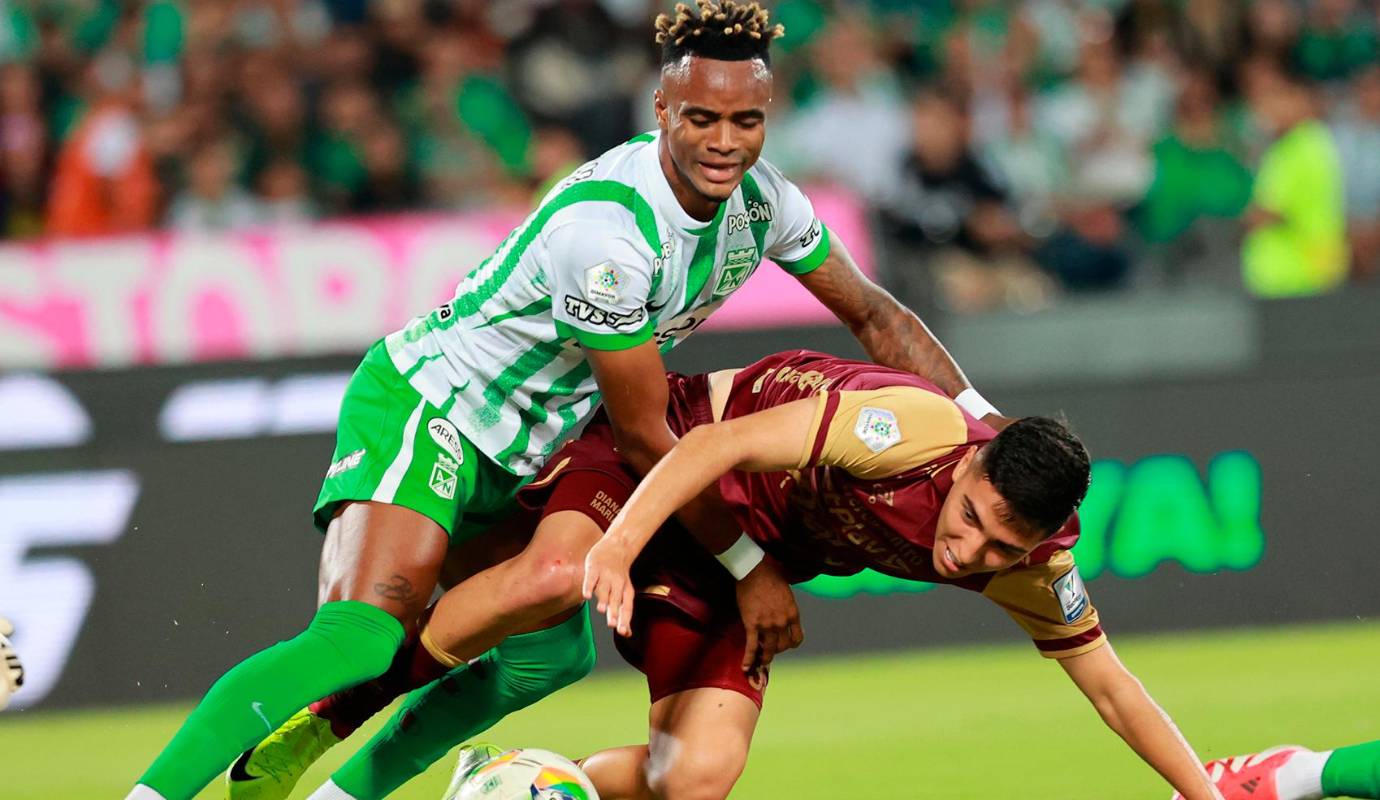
[{"x1": 331, "y1": 608, "x2": 595, "y2": 800}]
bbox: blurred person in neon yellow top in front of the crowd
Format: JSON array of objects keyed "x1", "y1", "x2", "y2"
[{"x1": 1242, "y1": 66, "x2": 1347, "y2": 298}]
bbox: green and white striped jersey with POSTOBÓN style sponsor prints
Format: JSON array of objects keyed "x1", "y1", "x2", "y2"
[{"x1": 386, "y1": 134, "x2": 829, "y2": 474}]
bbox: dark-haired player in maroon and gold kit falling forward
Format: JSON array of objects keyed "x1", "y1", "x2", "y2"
[{"x1": 296, "y1": 350, "x2": 1219, "y2": 800}]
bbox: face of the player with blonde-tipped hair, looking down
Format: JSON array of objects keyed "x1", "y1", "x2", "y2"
[{"x1": 656, "y1": 57, "x2": 771, "y2": 212}]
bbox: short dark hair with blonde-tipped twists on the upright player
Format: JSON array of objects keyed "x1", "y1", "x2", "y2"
[{"x1": 657, "y1": 0, "x2": 785, "y2": 65}]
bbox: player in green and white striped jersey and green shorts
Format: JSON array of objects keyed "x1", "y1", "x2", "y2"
[{"x1": 128, "y1": 0, "x2": 989, "y2": 800}]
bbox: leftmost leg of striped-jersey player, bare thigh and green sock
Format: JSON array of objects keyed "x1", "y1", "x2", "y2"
[{"x1": 131, "y1": 502, "x2": 447, "y2": 800}]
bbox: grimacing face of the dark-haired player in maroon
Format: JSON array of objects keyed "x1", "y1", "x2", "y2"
[{"x1": 934, "y1": 451, "x2": 1041, "y2": 578}]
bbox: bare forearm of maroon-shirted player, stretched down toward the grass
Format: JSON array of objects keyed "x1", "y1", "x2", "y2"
[{"x1": 1090, "y1": 676, "x2": 1220, "y2": 800}]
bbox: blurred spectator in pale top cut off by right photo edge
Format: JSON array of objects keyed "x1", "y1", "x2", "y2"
[{"x1": 1332, "y1": 65, "x2": 1380, "y2": 277}]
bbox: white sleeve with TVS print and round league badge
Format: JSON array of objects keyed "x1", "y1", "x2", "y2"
[{"x1": 545, "y1": 221, "x2": 654, "y2": 350}]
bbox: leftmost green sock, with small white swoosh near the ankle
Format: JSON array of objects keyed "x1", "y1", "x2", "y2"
[{"x1": 139, "y1": 600, "x2": 403, "y2": 800}]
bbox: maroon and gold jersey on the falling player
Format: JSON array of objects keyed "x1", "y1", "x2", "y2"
[{"x1": 719, "y1": 350, "x2": 1105, "y2": 658}]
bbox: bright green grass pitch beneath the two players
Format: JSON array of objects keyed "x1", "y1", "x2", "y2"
[{"x1": 0, "y1": 623, "x2": 1380, "y2": 800}]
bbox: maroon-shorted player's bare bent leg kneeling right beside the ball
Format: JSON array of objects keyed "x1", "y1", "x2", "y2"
[{"x1": 581, "y1": 688, "x2": 760, "y2": 800}]
